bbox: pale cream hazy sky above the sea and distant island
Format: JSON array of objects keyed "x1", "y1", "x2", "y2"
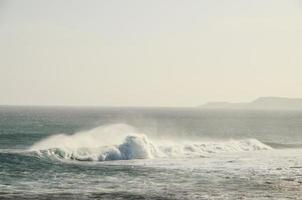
[{"x1": 0, "y1": 0, "x2": 302, "y2": 106}]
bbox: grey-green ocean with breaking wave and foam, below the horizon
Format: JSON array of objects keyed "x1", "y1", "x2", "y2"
[{"x1": 0, "y1": 106, "x2": 302, "y2": 200}]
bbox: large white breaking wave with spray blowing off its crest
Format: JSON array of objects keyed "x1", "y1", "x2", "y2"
[{"x1": 30, "y1": 124, "x2": 271, "y2": 161}]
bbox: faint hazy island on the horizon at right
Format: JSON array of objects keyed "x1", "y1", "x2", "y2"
[{"x1": 199, "y1": 97, "x2": 302, "y2": 110}]
